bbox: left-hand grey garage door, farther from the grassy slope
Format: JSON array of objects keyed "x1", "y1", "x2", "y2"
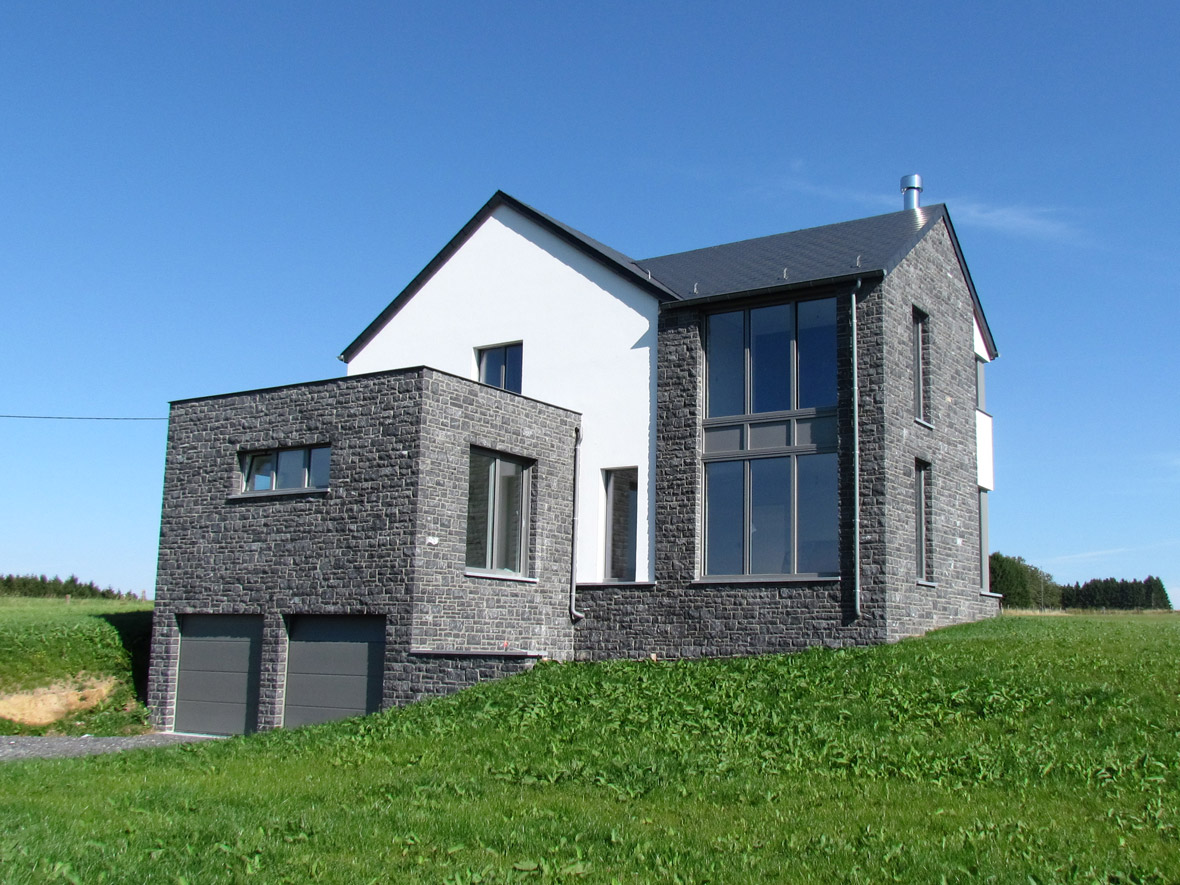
[{"x1": 173, "y1": 615, "x2": 262, "y2": 734}]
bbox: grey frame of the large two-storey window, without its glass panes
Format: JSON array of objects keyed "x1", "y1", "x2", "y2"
[{"x1": 700, "y1": 296, "x2": 840, "y2": 582}]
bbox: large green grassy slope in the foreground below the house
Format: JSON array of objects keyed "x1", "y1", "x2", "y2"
[{"x1": 0, "y1": 616, "x2": 1180, "y2": 883}]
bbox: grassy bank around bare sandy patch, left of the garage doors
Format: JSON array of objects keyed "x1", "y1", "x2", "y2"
[{"x1": 0, "y1": 597, "x2": 152, "y2": 735}]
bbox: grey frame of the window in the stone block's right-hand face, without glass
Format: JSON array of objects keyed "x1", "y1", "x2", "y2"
[{"x1": 464, "y1": 446, "x2": 536, "y2": 578}]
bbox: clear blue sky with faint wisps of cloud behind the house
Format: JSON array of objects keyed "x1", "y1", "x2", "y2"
[{"x1": 0, "y1": 2, "x2": 1180, "y2": 601}]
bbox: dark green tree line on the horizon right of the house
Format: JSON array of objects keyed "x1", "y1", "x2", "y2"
[{"x1": 988, "y1": 552, "x2": 1172, "y2": 611}]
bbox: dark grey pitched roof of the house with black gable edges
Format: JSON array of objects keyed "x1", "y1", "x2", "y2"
[{"x1": 340, "y1": 191, "x2": 998, "y2": 362}]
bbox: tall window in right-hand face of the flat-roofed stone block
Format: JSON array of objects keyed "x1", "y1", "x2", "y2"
[{"x1": 467, "y1": 448, "x2": 529, "y2": 575}]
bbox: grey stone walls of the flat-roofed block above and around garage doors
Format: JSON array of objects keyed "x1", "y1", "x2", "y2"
[{"x1": 149, "y1": 367, "x2": 579, "y2": 730}]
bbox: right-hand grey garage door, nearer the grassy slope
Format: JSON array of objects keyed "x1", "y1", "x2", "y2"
[{"x1": 283, "y1": 615, "x2": 385, "y2": 727}]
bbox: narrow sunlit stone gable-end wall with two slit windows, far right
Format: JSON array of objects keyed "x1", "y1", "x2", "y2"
[{"x1": 871, "y1": 222, "x2": 998, "y2": 641}]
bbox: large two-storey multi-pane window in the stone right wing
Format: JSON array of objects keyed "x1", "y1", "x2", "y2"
[{"x1": 702, "y1": 299, "x2": 839, "y2": 576}]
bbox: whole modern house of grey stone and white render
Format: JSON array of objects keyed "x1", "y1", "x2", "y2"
[{"x1": 149, "y1": 177, "x2": 998, "y2": 733}]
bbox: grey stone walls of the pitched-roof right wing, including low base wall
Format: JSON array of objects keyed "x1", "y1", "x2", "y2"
[{"x1": 575, "y1": 217, "x2": 997, "y2": 660}]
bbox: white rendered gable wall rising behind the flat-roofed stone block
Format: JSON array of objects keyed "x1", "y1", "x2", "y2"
[{"x1": 348, "y1": 207, "x2": 658, "y2": 582}]
